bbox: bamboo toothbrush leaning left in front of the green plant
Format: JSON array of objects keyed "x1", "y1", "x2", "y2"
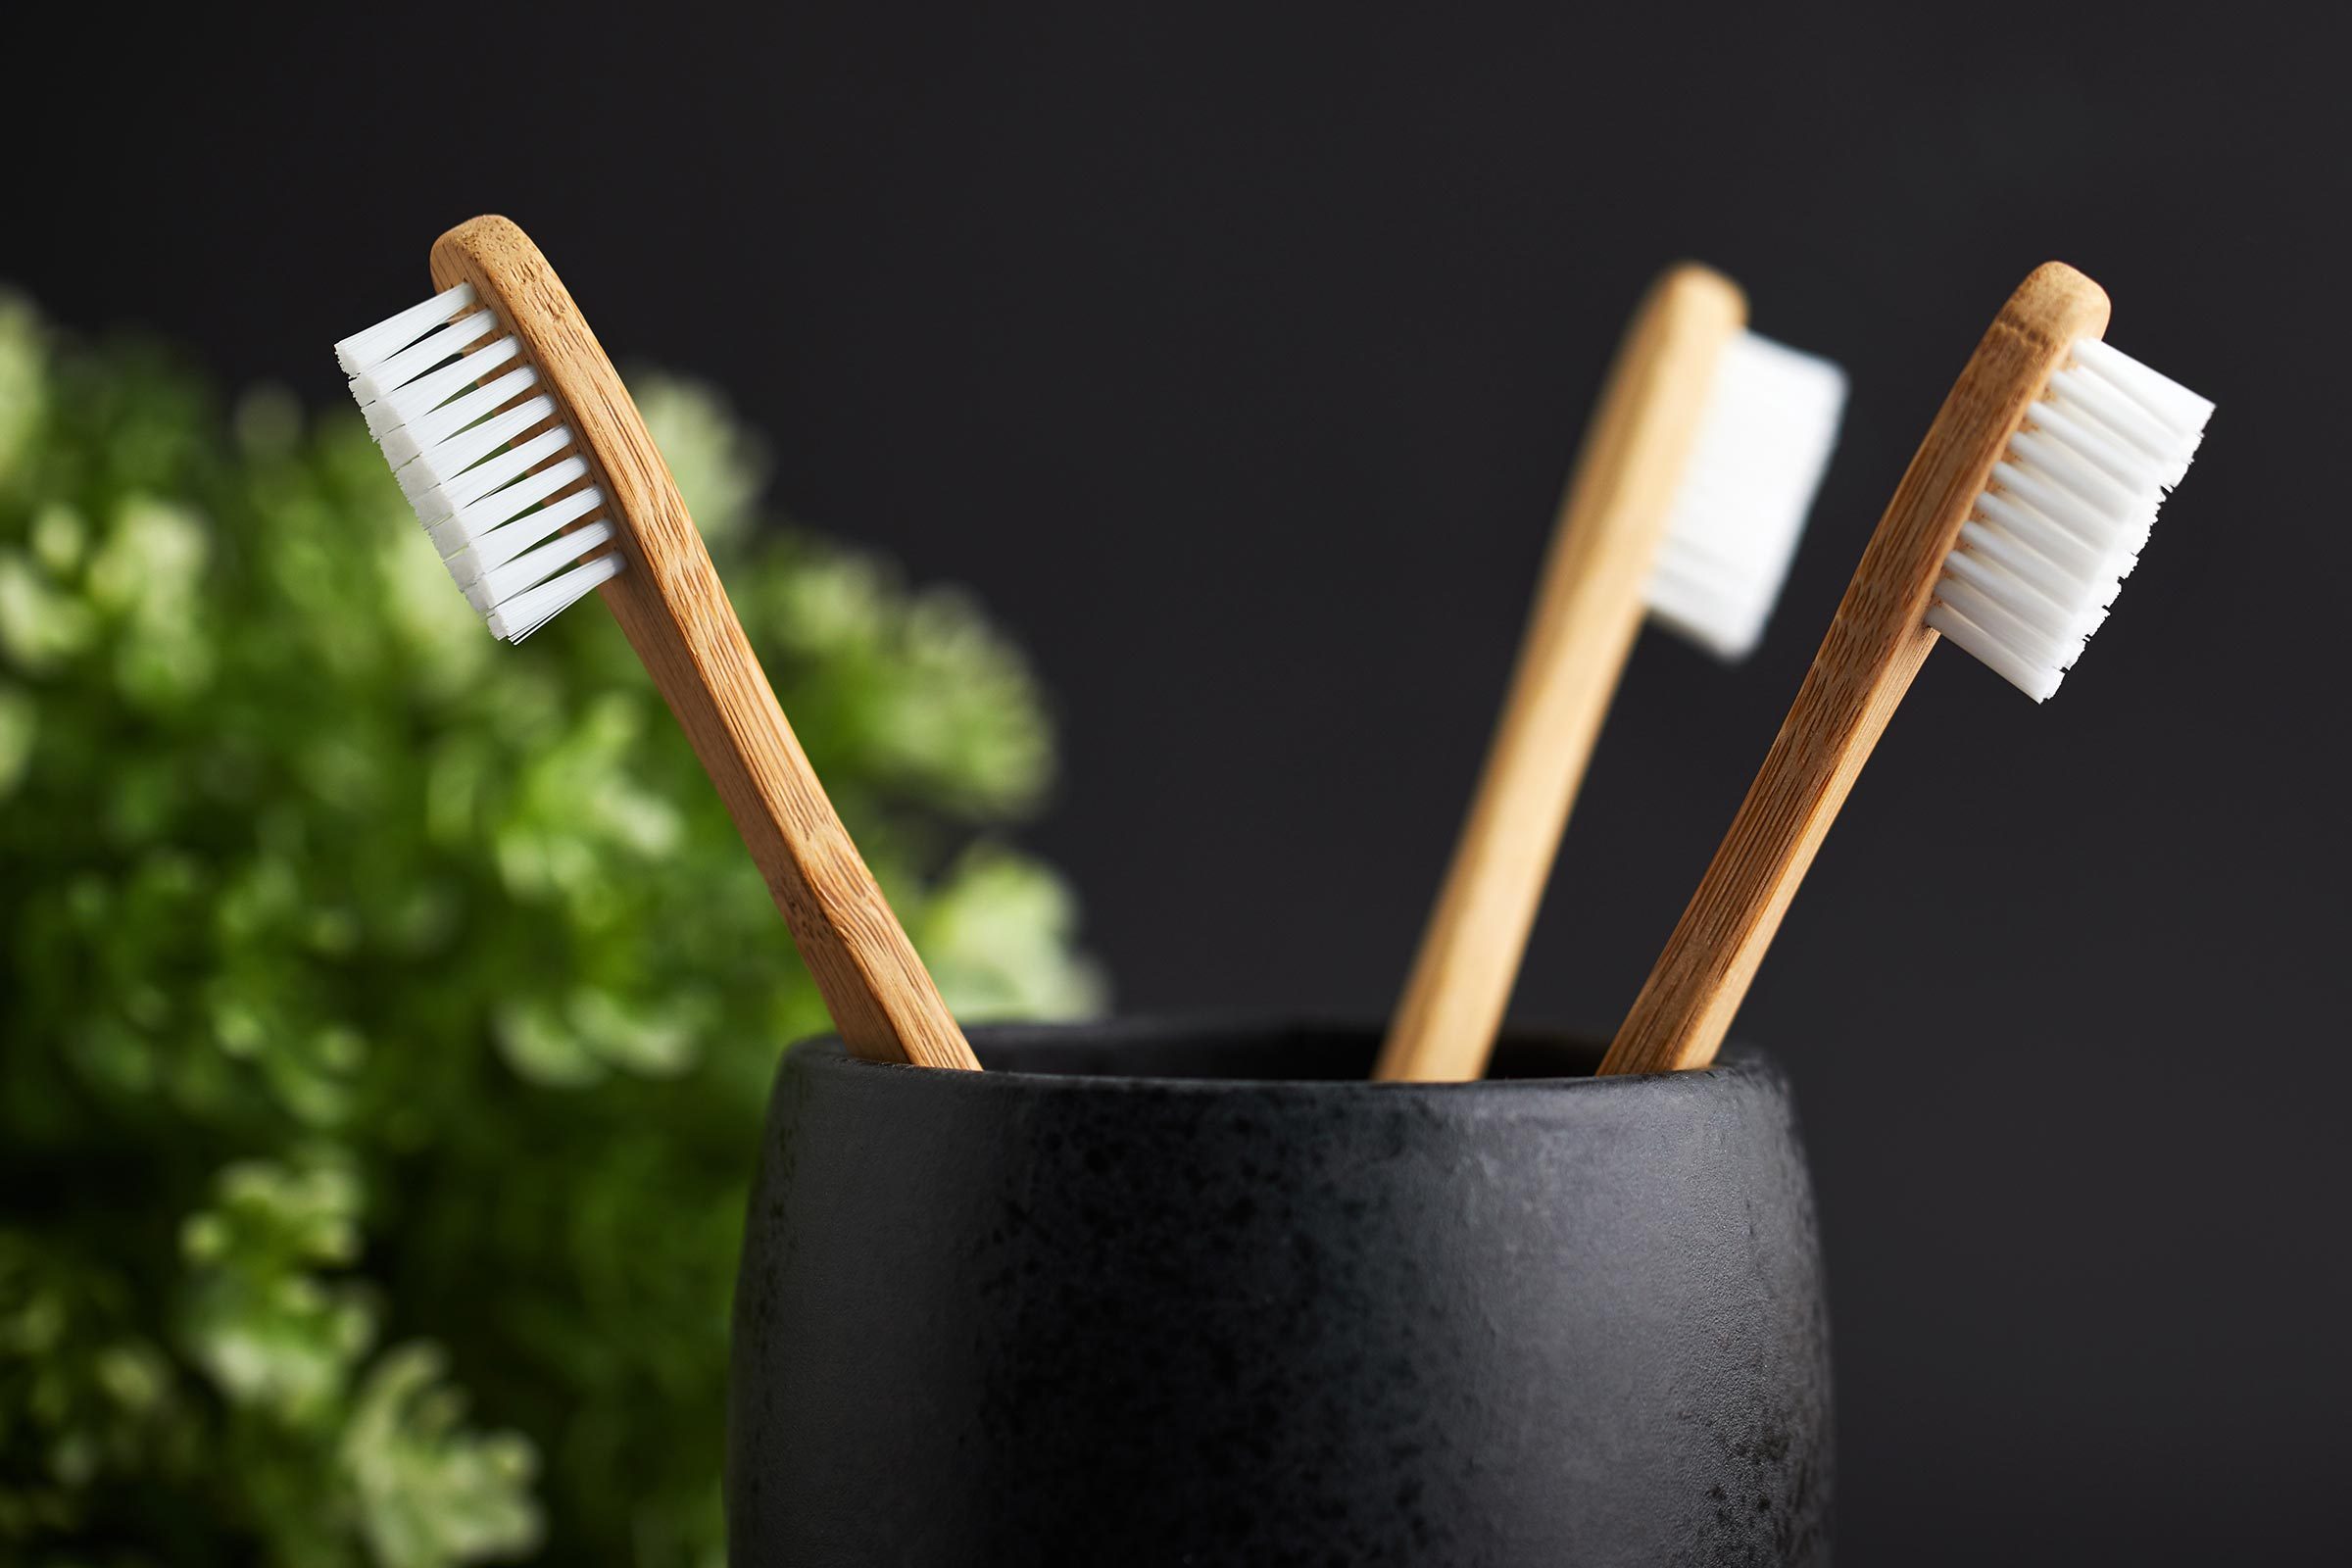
[{"x1": 336, "y1": 219, "x2": 978, "y2": 1067}]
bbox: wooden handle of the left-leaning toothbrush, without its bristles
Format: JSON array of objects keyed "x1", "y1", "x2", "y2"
[{"x1": 433, "y1": 217, "x2": 978, "y2": 1069}]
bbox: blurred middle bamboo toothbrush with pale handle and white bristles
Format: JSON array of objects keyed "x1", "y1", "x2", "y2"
[{"x1": 1374, "y1": 266, "x2": 1846, "y2": 1079}]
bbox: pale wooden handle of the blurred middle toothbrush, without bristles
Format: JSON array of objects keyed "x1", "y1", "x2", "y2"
[{"x1": 1374, "y1": 266, "x2": 1747, "y2": 1079}]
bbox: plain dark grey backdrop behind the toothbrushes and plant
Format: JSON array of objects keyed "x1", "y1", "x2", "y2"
[{"x1": 0, "y1": 0, "x2": 2352, "y2": 1563}]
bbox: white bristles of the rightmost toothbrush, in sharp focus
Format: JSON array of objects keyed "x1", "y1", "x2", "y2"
[{"x1": 1927, "y1": 338, "x2": 2213, "y2": 703}]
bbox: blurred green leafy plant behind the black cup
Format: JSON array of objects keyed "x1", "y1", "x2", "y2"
[{"x1": 0, "y1": 296, "x2": 1099, "y2": 1568}]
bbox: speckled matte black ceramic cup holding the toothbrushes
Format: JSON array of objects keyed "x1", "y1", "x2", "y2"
[{"x1": 727, "y1": 1020, "x2": 1830, "y2": 1568}]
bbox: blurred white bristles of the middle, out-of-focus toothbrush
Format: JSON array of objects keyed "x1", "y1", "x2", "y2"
[{"x1": 1648, "y1": 331, "x2": 1846, "y2": 659}]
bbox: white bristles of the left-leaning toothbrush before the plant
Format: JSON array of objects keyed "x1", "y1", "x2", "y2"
[{"x1": 334, "y1": 284, "x2": 621, "y2": 642}]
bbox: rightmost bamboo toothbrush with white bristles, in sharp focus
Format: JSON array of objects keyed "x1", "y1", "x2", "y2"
[{"x1": 1601, "y1": 261, "x2": 2213, "y2": 1072}]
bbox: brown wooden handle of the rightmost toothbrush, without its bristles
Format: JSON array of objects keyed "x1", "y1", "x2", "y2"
[{"x1": 1601, "y1": 261, "x2": 2107, "y2": 1072}]
